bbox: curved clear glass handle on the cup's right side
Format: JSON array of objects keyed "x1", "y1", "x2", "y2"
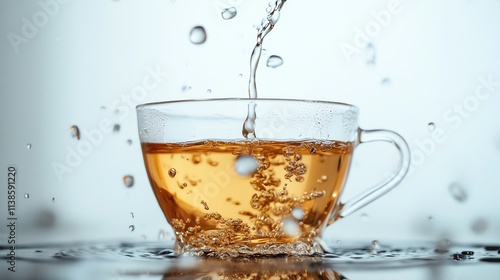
[{"x1": 334, "y1": 128, "x2": 410, "y2": 219}]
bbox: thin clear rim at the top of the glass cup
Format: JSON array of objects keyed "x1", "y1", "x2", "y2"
[{"x1": 135, "y1": 97, "x2": 359, "y2": 111}]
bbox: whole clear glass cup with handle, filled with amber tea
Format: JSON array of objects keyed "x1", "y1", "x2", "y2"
[{"x1": 137, "y1": 99, "x2": 409, "y2": 257}]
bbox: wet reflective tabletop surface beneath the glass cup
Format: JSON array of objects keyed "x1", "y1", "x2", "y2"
[{"x1": 0, "y1": 242, "x2": 500, "y2": 280}]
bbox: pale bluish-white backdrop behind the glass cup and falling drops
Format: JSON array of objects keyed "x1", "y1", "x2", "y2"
[{"x1": 0, "y1": 0, "x2": 500, "y2": 248}]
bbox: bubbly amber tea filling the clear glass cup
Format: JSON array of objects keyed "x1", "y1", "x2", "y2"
[{"x1": 142, "y1": 140, "x2": 353, "y2": 255}]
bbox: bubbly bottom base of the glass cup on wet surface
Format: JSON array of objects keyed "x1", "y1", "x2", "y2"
[{"x1": 176, "y1": 241, "x2": 324, "y2": 259}]
